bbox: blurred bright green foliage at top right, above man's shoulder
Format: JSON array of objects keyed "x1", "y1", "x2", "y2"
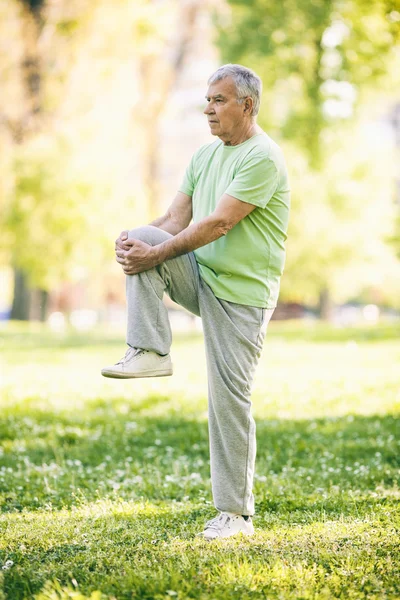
[{"x1": 219, "y1": 0, "x2": 400, "y2": 166}]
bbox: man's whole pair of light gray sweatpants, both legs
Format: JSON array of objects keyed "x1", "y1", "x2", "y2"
[{"x1": 126, "y1": 225, "x2": 274, "y2": 515}]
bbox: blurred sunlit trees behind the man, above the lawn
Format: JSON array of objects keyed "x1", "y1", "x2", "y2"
[{"x1": 0, "y1": 0, "x2": 400, "y2": 319}]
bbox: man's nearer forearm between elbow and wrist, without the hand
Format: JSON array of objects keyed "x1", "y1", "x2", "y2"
[{"x1": 153, "y1": 215, "x2": 229, "y2": 264}]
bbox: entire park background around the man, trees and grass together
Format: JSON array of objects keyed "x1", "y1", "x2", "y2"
[{"x1": 0, "y1": 0, "x2": 400, "y2": 600}]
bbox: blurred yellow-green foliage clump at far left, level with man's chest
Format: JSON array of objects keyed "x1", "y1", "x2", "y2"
[{"x1": 5, "y1": 136, "x2": 90, "y2": 290}]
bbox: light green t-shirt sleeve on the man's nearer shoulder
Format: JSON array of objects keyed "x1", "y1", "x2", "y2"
[{"x1": 225, "y1": 154, "x2": 278, "y2": 208}]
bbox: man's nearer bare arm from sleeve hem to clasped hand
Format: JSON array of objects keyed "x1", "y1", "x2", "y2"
[{"x1": 117, "y1": 194, "x2": 257, "y2": 275}]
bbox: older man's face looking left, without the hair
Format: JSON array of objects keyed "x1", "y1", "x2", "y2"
[{"x1": 204, "y1": 77, "x2": 249, "y2": 140}]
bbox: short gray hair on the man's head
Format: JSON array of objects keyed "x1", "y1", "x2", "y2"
[{"x1": 207, "y1": 63, "x2": 262, "y2": 117}]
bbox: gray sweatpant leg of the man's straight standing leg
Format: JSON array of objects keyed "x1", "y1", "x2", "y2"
[{"x1": 200, "y1": 283, "x2": 273, "y2": 515}]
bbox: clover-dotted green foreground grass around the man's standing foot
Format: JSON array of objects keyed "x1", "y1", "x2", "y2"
[{"x1": 0, "y1": 398, "x2": 399, "y2": 600}]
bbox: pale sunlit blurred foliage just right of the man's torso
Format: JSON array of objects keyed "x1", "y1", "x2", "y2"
[{"x1": 281, "y1": 124, "x2": 400, "y2": 307}]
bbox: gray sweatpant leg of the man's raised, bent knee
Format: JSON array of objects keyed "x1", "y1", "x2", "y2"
[{"x1": 126, "y1": 225, "x2": 200, "y2": 354}]
